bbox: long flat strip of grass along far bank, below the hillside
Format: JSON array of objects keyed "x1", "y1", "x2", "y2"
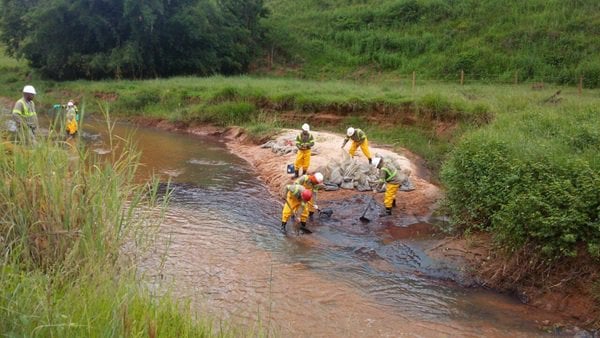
[{"x1": 0, "y1": 76, "x2": 598, "y2": 177}]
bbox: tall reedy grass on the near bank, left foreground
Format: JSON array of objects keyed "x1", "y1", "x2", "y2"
[{"x1": 0, "y1": 115, "x2": 236, "y2": 337}]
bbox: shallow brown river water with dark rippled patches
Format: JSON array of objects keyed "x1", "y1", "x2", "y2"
[{"x1": 82, "y1": 120, "x2": 543, "y2": 337}]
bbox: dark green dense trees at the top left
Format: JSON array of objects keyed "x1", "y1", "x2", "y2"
[{"x1": 0, "y1": 0, "x2": 267, "y2": 80}]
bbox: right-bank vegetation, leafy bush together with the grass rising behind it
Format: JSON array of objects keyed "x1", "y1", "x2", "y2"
[{"x1": 442, "y1": 108, "x2": 600, "y2": 259}]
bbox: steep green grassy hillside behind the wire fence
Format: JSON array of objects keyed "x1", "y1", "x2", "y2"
[{"x1": 267, "y1": 0, "x2": 600, "y2": 87}]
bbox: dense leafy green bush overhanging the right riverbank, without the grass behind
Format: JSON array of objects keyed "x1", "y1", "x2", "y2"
[{"x1": 441, "y1": 131, "x2": 600, "y2": 259}]
